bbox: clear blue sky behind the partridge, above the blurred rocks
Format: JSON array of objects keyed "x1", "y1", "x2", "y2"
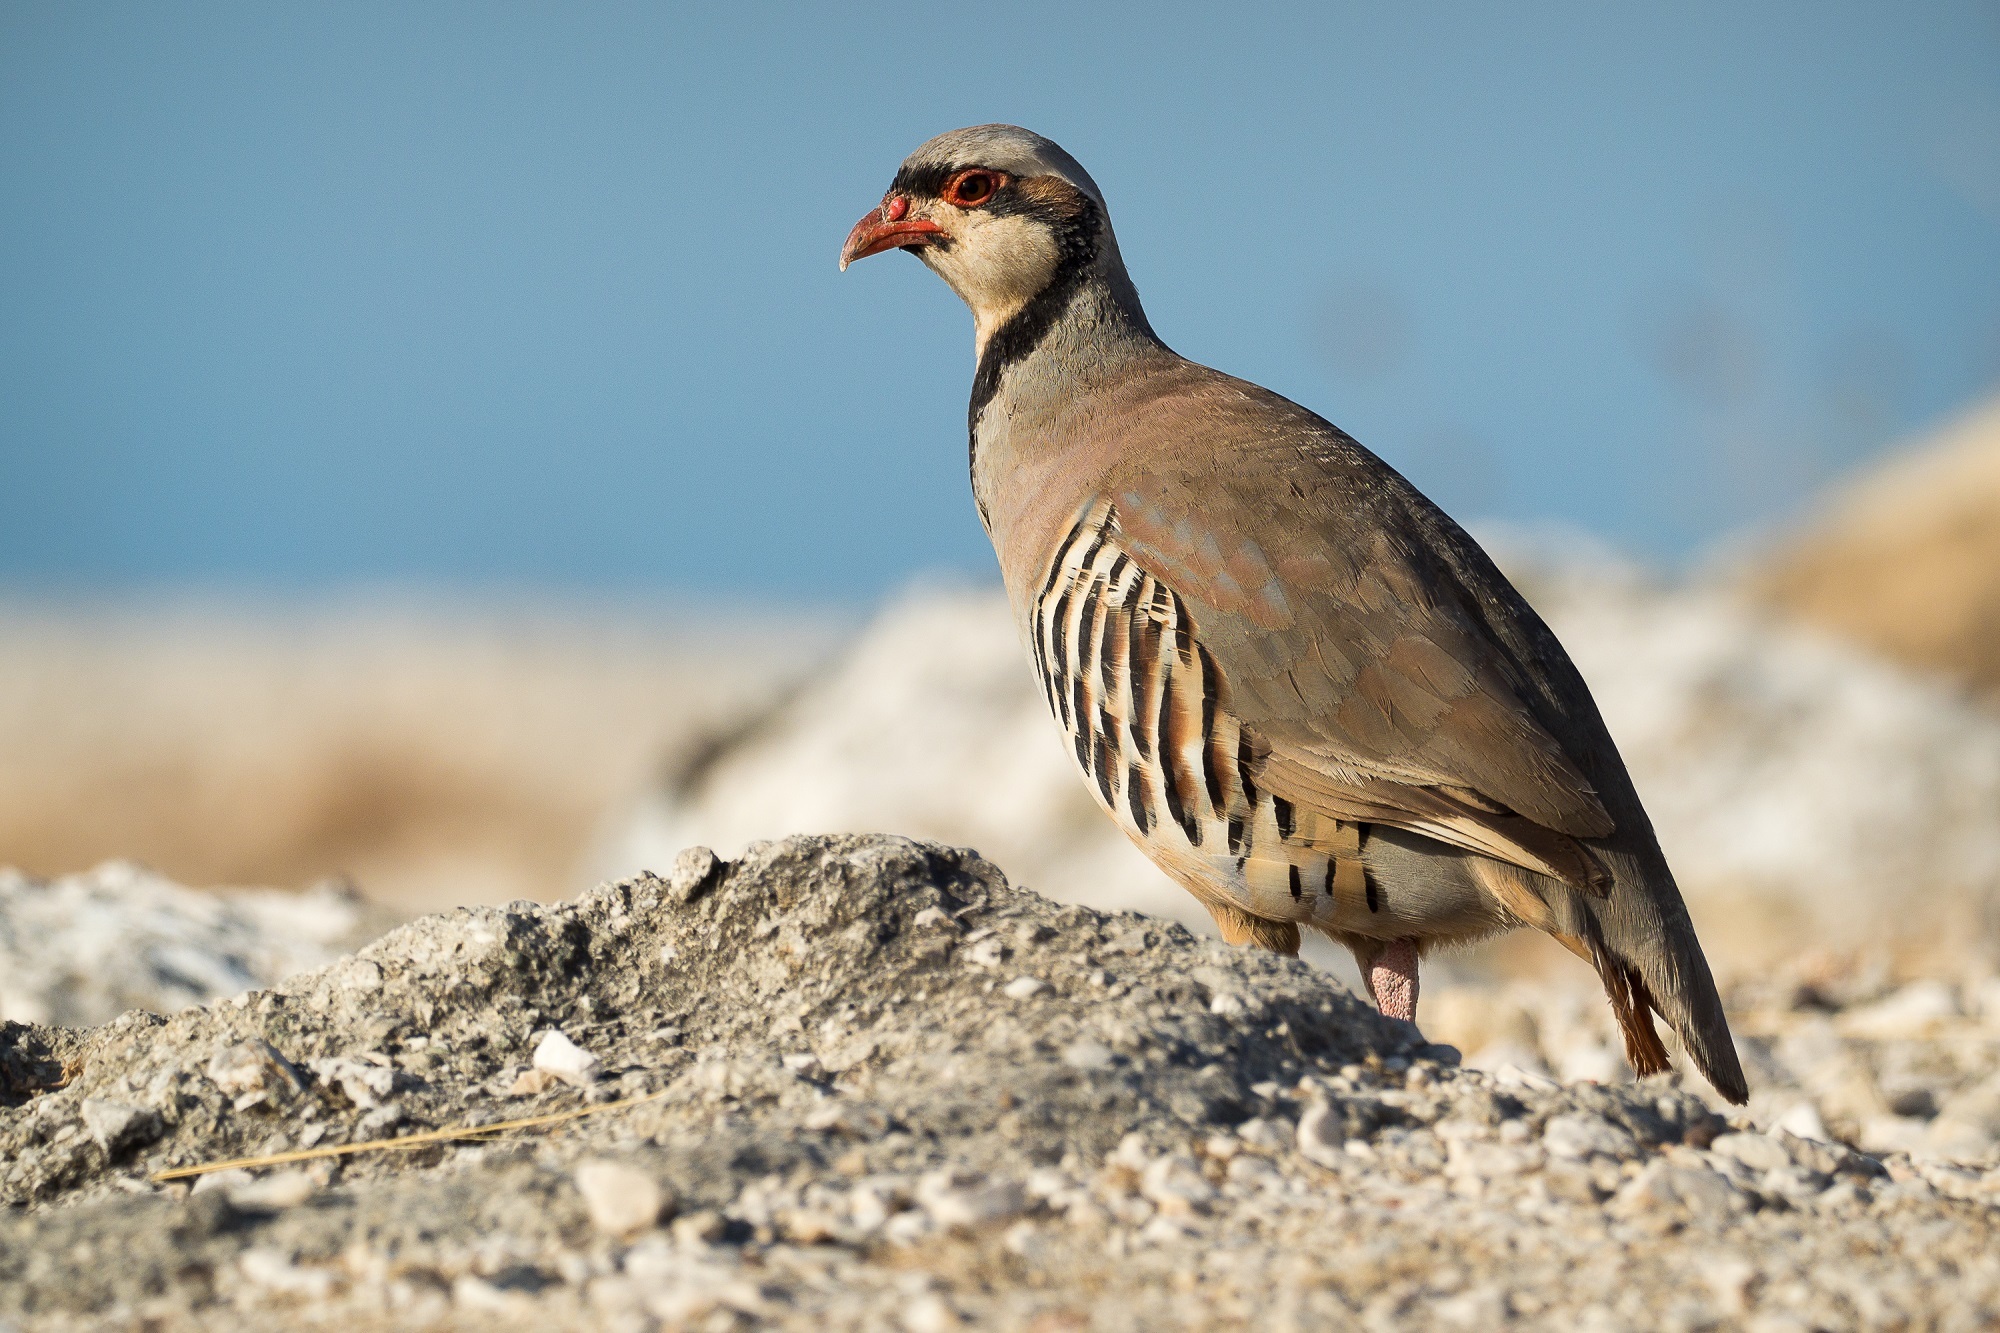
[{"x1": 0, "y1": 2, "x2": 2000, "y2": 600}]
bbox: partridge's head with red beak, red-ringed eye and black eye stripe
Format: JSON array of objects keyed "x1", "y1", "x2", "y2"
[{"x1": 840, "y1": 124, "x2": 1136, "y2": 350}]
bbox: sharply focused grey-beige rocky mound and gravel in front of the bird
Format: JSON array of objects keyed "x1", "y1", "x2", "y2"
[{"x1": 0, "y1": 837, "x2": 2000, "y2": 1333}]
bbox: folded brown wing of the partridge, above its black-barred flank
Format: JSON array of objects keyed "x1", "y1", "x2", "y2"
[{"x1": 1096, "y1": 390, "x2": 1614, "y2": 887}]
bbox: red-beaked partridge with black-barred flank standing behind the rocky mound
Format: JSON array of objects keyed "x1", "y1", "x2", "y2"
[{"x1": 840, "y1": 124, "x2": 1748, "y2": 1103}]
